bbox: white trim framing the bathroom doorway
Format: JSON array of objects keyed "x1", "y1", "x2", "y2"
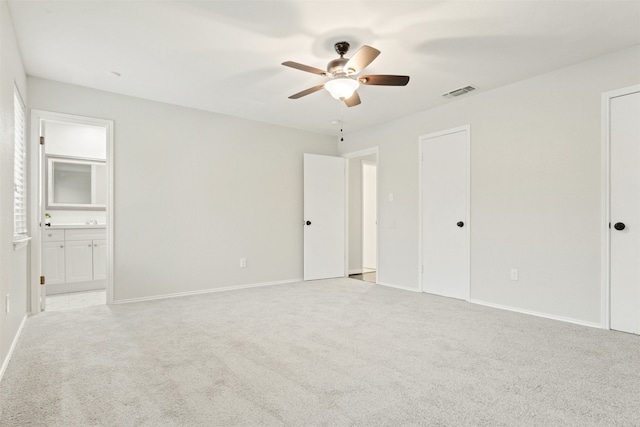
[{"x1": 29, "y1": 109, "x2": 115, "y2": 315}]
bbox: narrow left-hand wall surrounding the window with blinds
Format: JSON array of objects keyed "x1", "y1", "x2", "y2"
[{"x1": 0, "y1": 0, "x2": 29, "y2": 374}]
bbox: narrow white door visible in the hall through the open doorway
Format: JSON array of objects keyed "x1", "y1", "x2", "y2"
[{"x1": 362, "y1": 160, "x2": 378, "y2": 272}]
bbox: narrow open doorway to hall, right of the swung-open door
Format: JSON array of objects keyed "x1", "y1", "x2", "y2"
[{"x1": 345, "y1": 148, "x2": 379, "y2": 283}]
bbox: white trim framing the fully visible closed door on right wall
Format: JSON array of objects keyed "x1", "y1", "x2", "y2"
[{"x1": 418, "y1": 125, "x2": 472, "y2": 301}]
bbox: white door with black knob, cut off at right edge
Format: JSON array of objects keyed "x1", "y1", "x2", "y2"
[{"x1": 609, "y1": 92, "x2": 640, "y2": 334}]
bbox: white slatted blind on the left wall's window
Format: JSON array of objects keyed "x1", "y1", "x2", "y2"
[{"x1": 13, "y1": 89, "x2": 27, "y2": 240}]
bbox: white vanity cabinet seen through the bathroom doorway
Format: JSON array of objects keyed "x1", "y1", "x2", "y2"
[{"x1": 43, "y1": 227, "x2": 107, "y2": 295}]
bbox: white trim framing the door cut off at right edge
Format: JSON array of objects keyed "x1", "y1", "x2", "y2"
[{"x1": 600, "y1": 84, "x2": 640, "y2": 329}]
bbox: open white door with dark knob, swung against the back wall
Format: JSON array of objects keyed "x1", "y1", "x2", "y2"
[{"x1": 304, "y1": 154, "x2": 345, "y2": 280}]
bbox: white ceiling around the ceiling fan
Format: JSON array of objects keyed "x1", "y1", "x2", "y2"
[{"x1": 9, "y1": 0, "x2": 640, "y2": 135}]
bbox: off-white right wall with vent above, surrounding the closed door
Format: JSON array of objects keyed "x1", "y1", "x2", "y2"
[{"x1": 339, "y1": 47, "x2": 640, "y2": 323}]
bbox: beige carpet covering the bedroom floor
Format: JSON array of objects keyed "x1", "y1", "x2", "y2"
[{"x1": 0, "y1": 279, "x2": 640, "y2": 426}]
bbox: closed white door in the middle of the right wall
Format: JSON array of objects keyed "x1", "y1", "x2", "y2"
[{"x1": 420, "y1": 127, "x2": 469, "y2": 299}]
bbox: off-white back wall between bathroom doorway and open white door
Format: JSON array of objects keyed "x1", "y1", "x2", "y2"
[{"x1": 29, "y1": 78, "x2": 337, "y2": 301}]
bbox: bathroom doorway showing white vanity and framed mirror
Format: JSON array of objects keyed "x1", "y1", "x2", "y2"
[{"x1": 31, "y1": 110, "x2": 113, "y2": 313}]
